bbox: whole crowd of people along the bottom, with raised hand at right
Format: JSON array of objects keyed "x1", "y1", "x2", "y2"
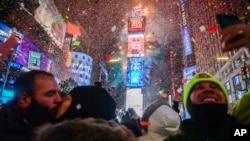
[{"x1": 0, "y1": 17, "x2": 250, "y2": 141}]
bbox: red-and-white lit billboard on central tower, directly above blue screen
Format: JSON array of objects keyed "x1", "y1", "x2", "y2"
[{"x1": 127, "y1": 34, "x2": 144, "y2": 57}]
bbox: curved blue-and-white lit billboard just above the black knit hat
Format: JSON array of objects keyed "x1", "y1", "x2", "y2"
[{"x1": 70, "y1": 52, "x2": 93, "y2": 86}]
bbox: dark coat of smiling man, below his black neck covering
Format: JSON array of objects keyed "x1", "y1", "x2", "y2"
[{"x1": 164, "y1": 116, "x2": 235, "y2": 141}]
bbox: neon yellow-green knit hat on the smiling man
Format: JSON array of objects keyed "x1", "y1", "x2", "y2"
[{"x1": 183, "y1": 72, "x2": 228, "y2": 112}]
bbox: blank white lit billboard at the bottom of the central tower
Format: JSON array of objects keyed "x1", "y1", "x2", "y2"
[{"x1": 126, "y1": 88, "x2": 143, "y2": 117}]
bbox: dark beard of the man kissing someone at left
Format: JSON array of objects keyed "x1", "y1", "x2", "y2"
[{"x1": 26, "y1": 99, "x2": 54, "y2": 127}]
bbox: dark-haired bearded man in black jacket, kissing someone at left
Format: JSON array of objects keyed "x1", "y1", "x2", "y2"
[{"x1": 0, "y1": 70, "x2": 62, "y2": 141}]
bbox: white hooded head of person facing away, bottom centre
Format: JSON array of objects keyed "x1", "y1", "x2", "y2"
[{"x1": 139, "y1": 101, "x2": 181, "y2": 141}]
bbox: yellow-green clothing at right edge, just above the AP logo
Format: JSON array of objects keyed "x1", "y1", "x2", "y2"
[{"x1": 232, "y1": 91, "x2": 250, "y2": 124}]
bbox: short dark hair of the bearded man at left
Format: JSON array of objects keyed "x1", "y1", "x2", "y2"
[{"x1": 13, "y1": 70, "x2": 54, "y2": 101}]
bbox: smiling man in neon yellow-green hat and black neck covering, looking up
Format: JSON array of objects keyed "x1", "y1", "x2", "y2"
[{"x1": 165, "y1": 73, "x2": 234, "y2": 141}]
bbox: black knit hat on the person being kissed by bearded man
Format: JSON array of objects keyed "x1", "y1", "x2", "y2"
[{"x1": 59, "y1": 86, "x2": 116, "y2": 120}]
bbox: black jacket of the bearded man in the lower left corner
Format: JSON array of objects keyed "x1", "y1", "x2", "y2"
[{"x1": 0, "y1": 101, "x2": 33, "y2": 141}]
